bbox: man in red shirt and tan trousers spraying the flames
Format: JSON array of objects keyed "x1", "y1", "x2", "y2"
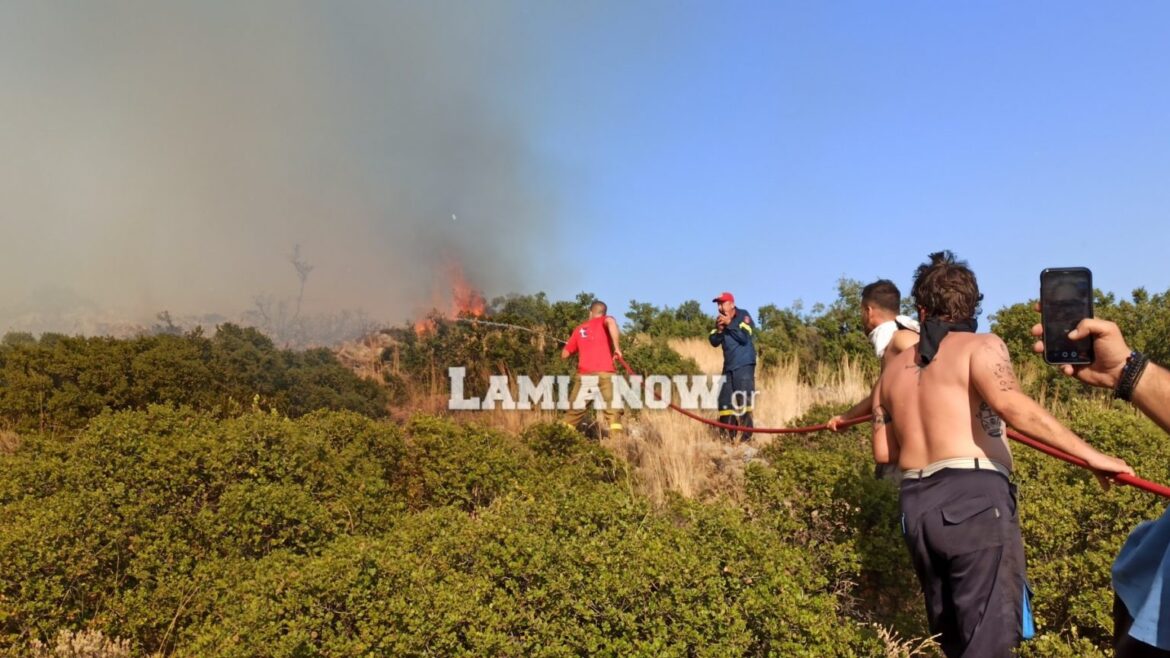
[{"x1": 560, "y1": 301, "x2": 622, "y2": 437}]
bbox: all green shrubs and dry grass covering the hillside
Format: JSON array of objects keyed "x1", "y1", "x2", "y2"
[{"x1": 0, "y1": 287, "x2": 1170, "y2": 657}]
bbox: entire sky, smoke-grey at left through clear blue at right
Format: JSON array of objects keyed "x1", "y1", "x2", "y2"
[{"x1": 0, "y1": 0, "x2": 1170, "y2": 331}]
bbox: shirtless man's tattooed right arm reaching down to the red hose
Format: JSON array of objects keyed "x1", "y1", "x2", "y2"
[{"x1": 971, "y1": 335, "x2": 1134, "y2": 484}]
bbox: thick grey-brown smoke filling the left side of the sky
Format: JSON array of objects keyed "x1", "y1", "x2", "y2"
[{"x1": 0, "y1": 1, "x2": 551, "y2": 331}]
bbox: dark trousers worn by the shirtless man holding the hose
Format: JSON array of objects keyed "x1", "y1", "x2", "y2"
[{"x1": 899, "y1": 468, "x2": 1026, "y2": 658}]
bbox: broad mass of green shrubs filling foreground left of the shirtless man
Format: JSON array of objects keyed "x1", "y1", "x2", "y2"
[{"x1": 0, "y1": 406, "x2": 880, "y2": 656}]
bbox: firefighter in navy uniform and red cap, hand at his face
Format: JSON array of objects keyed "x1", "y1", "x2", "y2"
[{"x1": 709, "y1": 293, "x2": 756, "y2": 441}]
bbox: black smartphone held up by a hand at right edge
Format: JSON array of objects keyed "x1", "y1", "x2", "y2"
[{"x1": 1040, "y1": 267, "x2": 1093, "y2": 364}]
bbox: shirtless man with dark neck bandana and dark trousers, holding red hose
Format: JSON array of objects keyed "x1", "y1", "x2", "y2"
[{"x1": 873, "y1": 252, "x2": 1133, "y2": 658}]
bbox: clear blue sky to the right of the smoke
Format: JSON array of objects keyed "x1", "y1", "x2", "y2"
[{"x1": 524, "y1": 2, "x2": 1170, "y2": 315}]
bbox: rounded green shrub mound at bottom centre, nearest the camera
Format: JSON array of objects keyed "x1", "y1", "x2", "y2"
[{"x1": 180, "y1": 485, "x2": 876, "y2": 657}]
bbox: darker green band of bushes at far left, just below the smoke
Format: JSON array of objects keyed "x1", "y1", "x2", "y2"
[{"x1": 0, "y1": 324, "x2": 387, "y2": 432}]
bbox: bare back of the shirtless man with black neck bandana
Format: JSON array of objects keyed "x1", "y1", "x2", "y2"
[{"x1": 874, "y1": 333, "x2": 1018, "y2": 471}]
